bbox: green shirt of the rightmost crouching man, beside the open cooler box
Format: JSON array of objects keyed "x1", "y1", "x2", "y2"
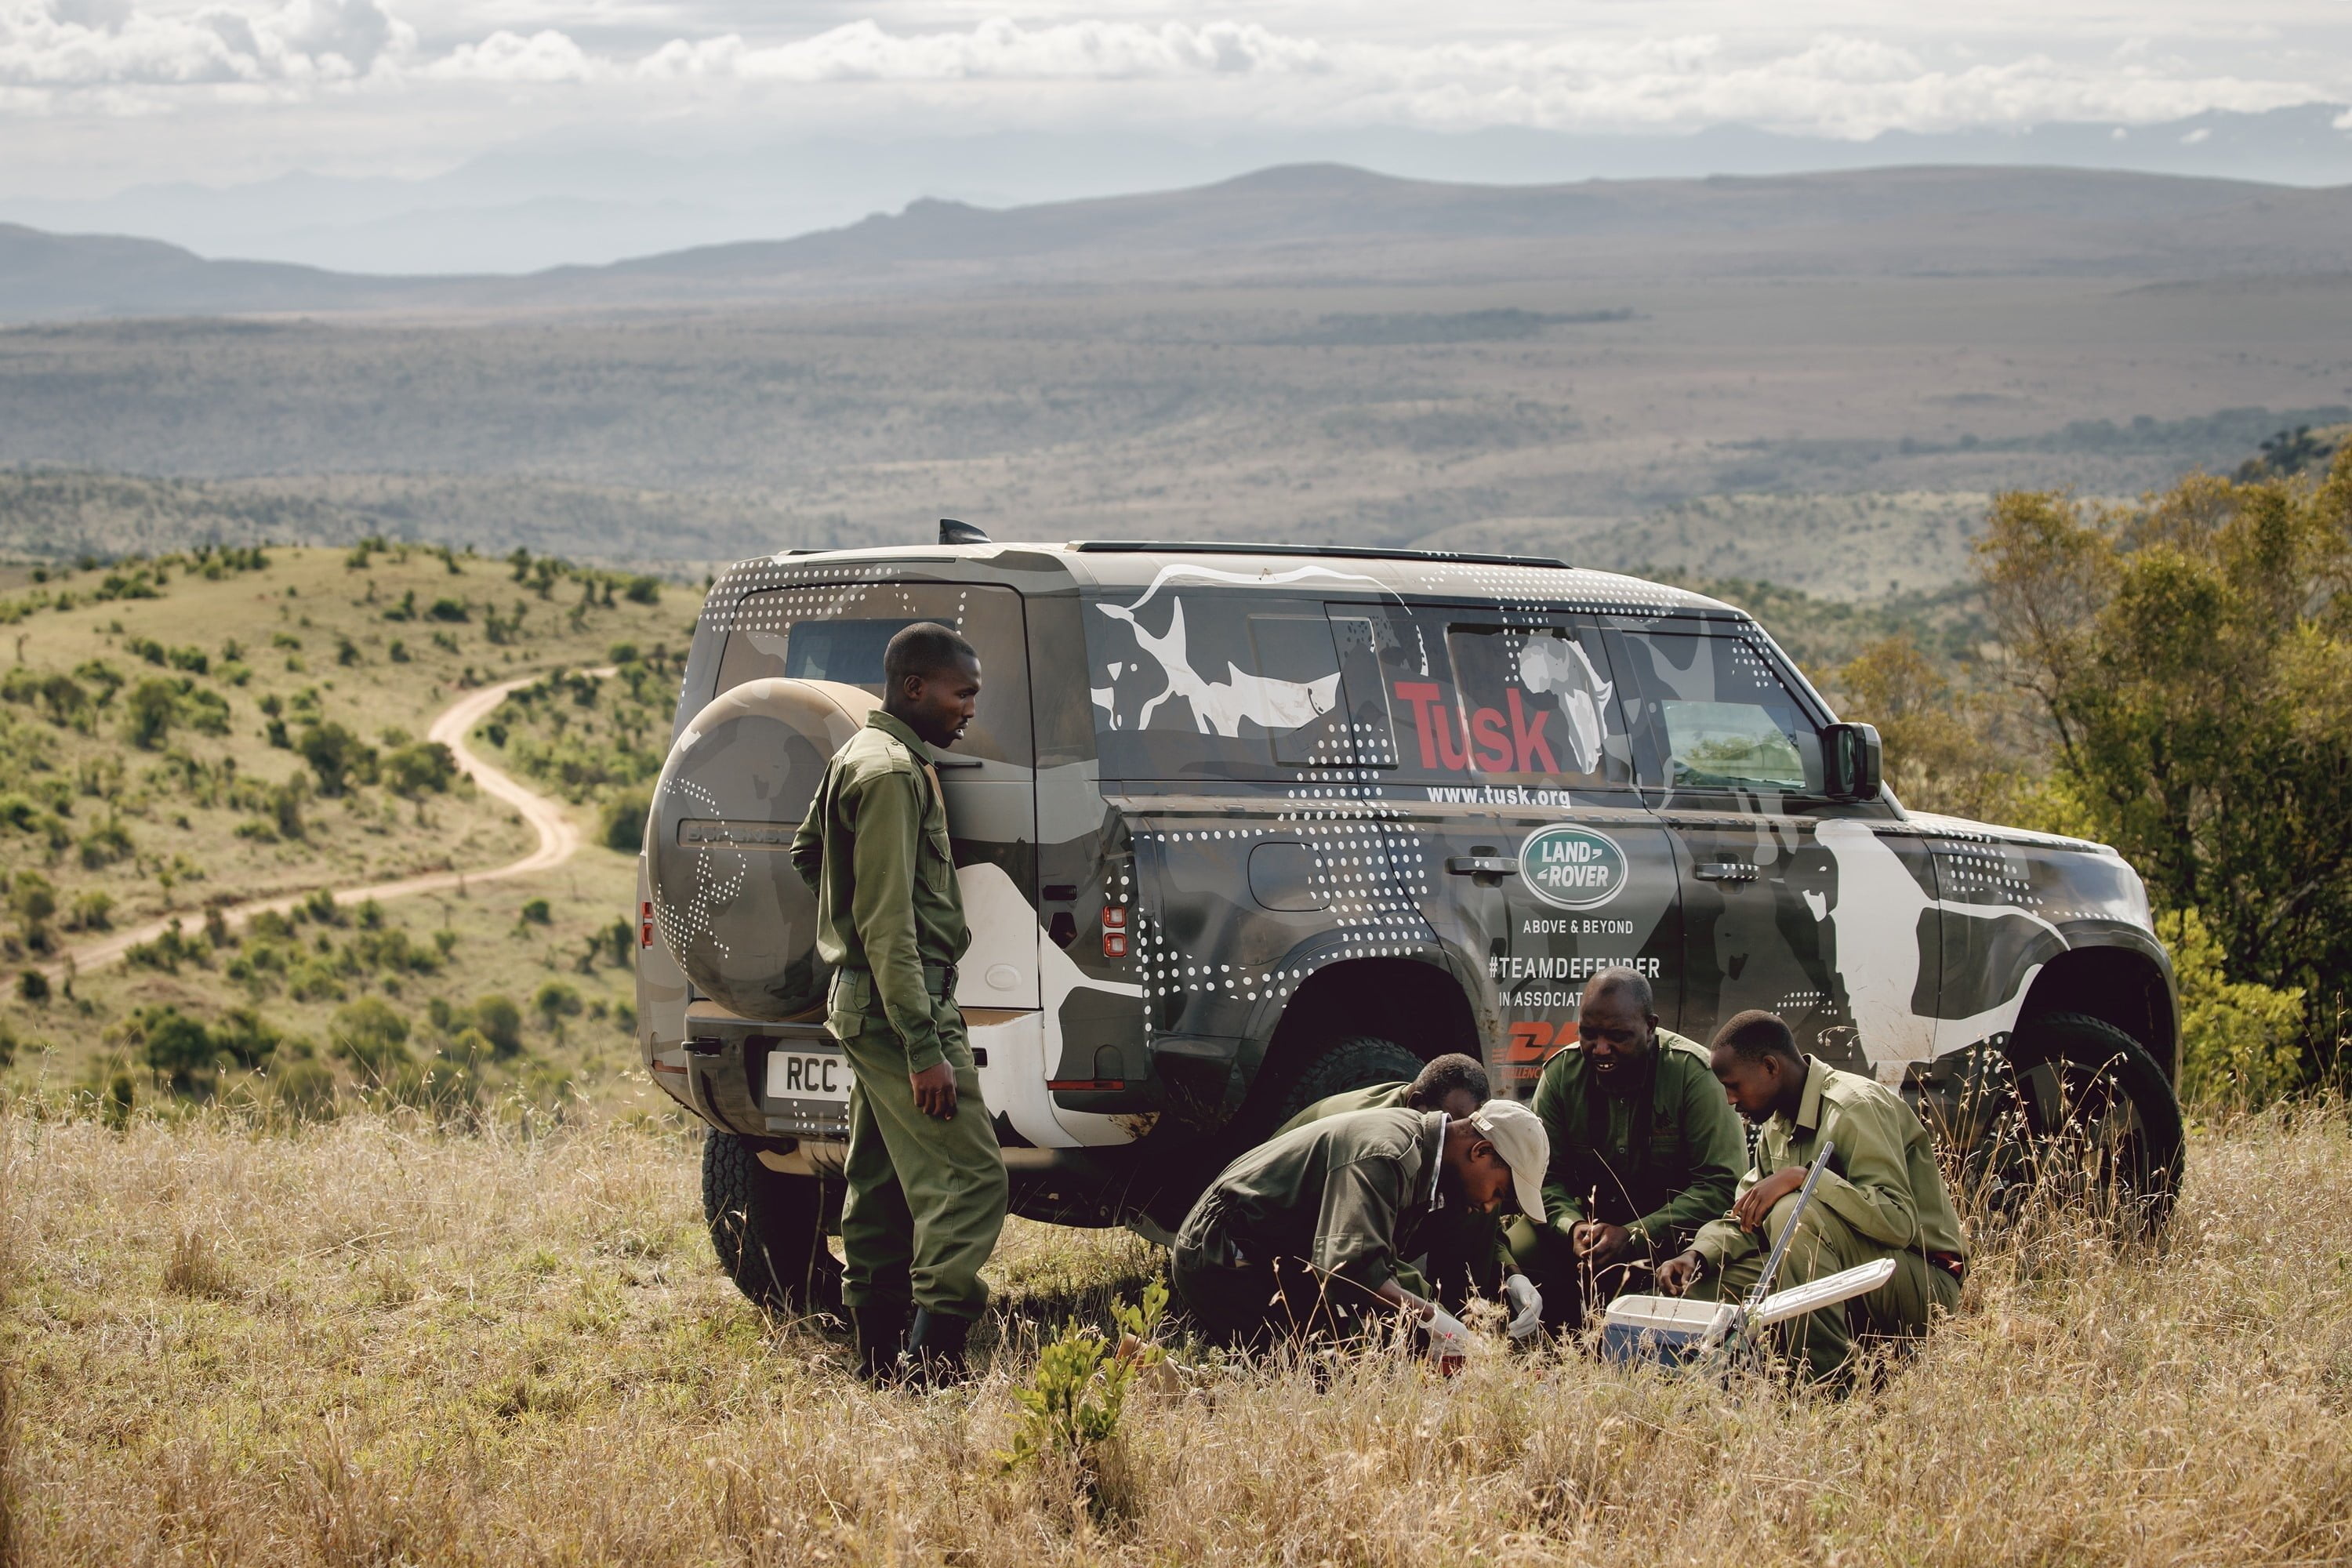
[{"x1": 1691, "y1": 1055, "x2": 1969, "y2": 1267}]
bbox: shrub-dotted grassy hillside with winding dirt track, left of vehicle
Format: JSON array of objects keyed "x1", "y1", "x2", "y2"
[{"x1": 0, "y1": 546, "x2": 694, "y2": 1105}]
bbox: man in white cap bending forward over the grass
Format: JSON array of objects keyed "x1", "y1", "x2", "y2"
[{"x1": 1169, "y1": 1100, "x2": 1550, "y2": 1342}]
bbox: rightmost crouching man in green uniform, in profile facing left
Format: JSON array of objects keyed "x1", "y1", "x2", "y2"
[{"x1": 1658, "y1": 1013, "x2": 1969, "y2": 1377}]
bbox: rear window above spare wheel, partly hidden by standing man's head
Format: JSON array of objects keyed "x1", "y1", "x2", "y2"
[{"x1": 713, "y1": 583, "x2": 1033, "y2": 767}]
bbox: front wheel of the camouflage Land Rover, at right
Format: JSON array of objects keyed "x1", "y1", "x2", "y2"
[{"x1": 1945, "y1": 1013, "x2": 2183, "y2": 1232}]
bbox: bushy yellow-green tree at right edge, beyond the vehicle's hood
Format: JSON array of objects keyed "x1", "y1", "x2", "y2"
[{"x1": 1980, "y1": 449, "x2": 2352, "y2": 1081}]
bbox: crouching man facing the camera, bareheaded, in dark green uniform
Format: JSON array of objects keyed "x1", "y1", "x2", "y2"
[{"x1": 1508, "y1": 968, "x2": 1748, "y2": 1328}]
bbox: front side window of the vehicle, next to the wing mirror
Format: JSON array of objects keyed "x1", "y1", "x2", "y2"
[{"x1": 1618, "y1": 630, "x2": 1820, "y2": 811}]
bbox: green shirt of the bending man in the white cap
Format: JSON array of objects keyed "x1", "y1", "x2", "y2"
[{"x1": 1176, "y1": 1109, "x2": 1444, "y2": 1290}]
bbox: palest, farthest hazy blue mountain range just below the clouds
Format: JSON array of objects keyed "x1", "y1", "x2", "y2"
[{"x1": 13, "y1": 103, "x2": 2352, "y2": 273}]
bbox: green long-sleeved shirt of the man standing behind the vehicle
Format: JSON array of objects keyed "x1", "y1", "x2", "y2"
[{"x1": 793, "y1": 708, "x2": 971, "y2": 1072}]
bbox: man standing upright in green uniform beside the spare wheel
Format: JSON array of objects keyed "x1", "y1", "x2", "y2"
[{"x1": 793, "y1": 621, "x2": 1004, "y2": 1382}]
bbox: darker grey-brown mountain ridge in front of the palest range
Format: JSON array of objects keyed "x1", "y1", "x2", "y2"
[{"x1": 0, "y1": 165, "x2": 2352, "y2": 322}]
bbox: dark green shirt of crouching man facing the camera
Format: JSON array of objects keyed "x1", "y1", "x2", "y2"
[{"x1": 1534, "y1": 1029, "x2": 1748, "y2": 1248}]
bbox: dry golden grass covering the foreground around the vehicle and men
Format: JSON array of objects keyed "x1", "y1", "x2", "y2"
[{"x1": 0, "y1": 1107, "x2": 2352, "y2": 1568}]
